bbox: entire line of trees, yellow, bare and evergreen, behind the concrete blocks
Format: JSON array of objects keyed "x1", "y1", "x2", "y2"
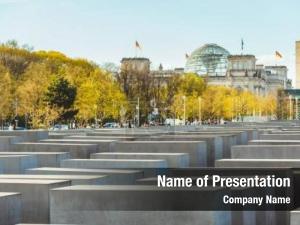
[{"x1": 0, "y1": 41, "x2": 276, "y2": 128}]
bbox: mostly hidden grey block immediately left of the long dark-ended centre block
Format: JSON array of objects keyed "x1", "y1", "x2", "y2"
[{"x1": 41, "y1": 138, "x2": 115, "y2": 152}]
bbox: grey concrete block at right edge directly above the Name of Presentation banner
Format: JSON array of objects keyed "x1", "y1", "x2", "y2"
[{"x1": 216, "y1": 159, "x2": 300, "y2": 168}]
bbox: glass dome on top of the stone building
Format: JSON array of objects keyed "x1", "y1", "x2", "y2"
[{"x1": 185, "y1": 44, "x2": 230, "y2": 76}]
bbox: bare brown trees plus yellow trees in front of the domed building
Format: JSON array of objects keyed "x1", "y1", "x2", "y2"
[{"x1": 118, "y1": 64, "x2": 276, "y2": 122}]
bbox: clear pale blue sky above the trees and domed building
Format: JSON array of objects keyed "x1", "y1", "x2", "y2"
[{"x1": 0, "y1": 0, "x2": 300, "y2": 80}]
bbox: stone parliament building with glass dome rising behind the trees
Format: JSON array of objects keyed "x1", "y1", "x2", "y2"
[{"x1": 121, "y1": 44, "x2": 290, "y2": 96}]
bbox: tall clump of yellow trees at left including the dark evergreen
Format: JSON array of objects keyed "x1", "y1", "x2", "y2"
[{"x1": 0, "y1": 42, "x2": 127, "y2": 128}]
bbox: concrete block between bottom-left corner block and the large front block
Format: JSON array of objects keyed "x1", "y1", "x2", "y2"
[{"x1": 0, "y1": 179, "x2": 71, "y2": 223}]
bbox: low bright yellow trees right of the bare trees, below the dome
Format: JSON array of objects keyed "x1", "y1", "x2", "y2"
[{"x1": 172, "y1": 82, "x2": 276, "y2": 121}]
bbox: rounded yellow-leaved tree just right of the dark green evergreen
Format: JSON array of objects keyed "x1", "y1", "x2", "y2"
[{"x1": 75, "y1": 69, "x2": 128, "y2": 125}]
